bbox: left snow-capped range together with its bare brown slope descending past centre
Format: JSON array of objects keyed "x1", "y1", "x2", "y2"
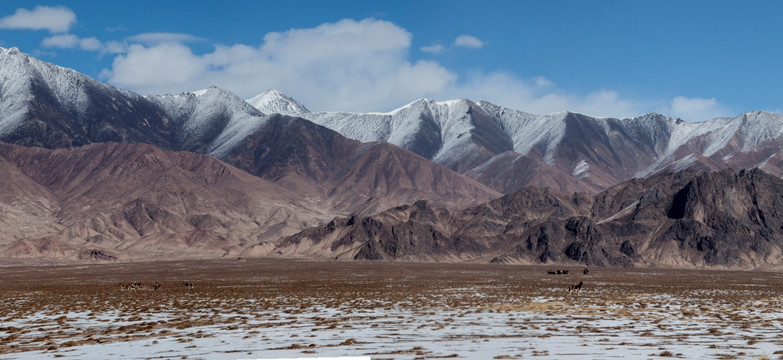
[{"x1": 0, "y1": 48, "x2": 499, "y2": 213}]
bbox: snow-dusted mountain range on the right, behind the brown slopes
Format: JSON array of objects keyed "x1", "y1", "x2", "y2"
[{"x1": 251, "y1": 82, "x2": 783, "y2": 193}]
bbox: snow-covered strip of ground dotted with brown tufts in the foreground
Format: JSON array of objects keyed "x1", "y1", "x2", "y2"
[{"x1": 3, "y1": 299, "x2": 783, "y2": 359}]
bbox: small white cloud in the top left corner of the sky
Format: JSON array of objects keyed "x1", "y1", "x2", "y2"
[{"x1": 0, "y1": 5, "x2": 76, "y2": 33}]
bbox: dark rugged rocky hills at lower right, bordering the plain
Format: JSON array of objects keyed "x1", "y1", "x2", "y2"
[{"x1": 270, "y1": 170, "x2": 783, "y2": 268}]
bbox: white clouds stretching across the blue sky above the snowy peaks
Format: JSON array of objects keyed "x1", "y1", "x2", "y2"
[{"x1": 0, "y1": 6, "x2": 734, "y2": 121}]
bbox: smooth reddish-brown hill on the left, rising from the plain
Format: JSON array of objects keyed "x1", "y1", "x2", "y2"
[{"x1": 0, "y1": 143, "x2": 333, "y2": 259}]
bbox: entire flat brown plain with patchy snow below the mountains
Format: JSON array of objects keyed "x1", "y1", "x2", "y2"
[{"x1": 0, "y1": 259, "x2": 783, "y2": 359}]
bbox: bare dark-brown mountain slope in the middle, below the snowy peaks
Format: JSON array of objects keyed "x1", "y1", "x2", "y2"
[{"x1": 217, "y1": 115, "x2": 500, "y2": 215}]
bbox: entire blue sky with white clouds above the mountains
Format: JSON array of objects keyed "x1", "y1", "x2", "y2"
[{"x1": 0, "y1": 0, "x2": 783, "y2": 121}]
